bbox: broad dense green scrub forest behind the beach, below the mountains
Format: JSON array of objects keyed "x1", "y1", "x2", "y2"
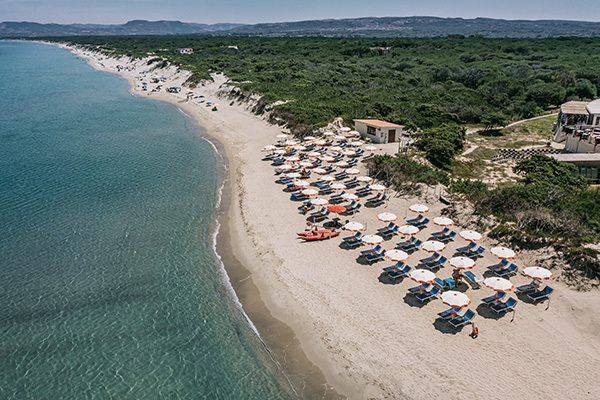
[{"x1": 65, "y1": 36, "x2": 600, "y2": 129}]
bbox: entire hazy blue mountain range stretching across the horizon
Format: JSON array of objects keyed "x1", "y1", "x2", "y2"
[{"x1": 0, "y1": 17, "x2": 600, "y2": 38}]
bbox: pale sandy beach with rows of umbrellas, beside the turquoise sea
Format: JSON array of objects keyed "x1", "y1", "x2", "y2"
[{"x1": 65, "y1": 45, "x2": 600, "y2": 399}]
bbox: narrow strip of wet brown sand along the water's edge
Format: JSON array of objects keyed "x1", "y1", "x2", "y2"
[{"x1": 58, "y1": 42, "x2": 342, "y2": 399}]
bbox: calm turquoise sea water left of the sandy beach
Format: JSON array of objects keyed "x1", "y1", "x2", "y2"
[{"x1": 0, "y1": 41, "x2": 289, "y2": 399}]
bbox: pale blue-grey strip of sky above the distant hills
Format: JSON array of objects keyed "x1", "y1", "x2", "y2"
[{"x1": 0, "y1": 0, "x2": 600, "y2": 24}]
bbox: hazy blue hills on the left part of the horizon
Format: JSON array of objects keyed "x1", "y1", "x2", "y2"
[{"x1": 0, "y1": 20, "x2": 242, "y2": 38}]
